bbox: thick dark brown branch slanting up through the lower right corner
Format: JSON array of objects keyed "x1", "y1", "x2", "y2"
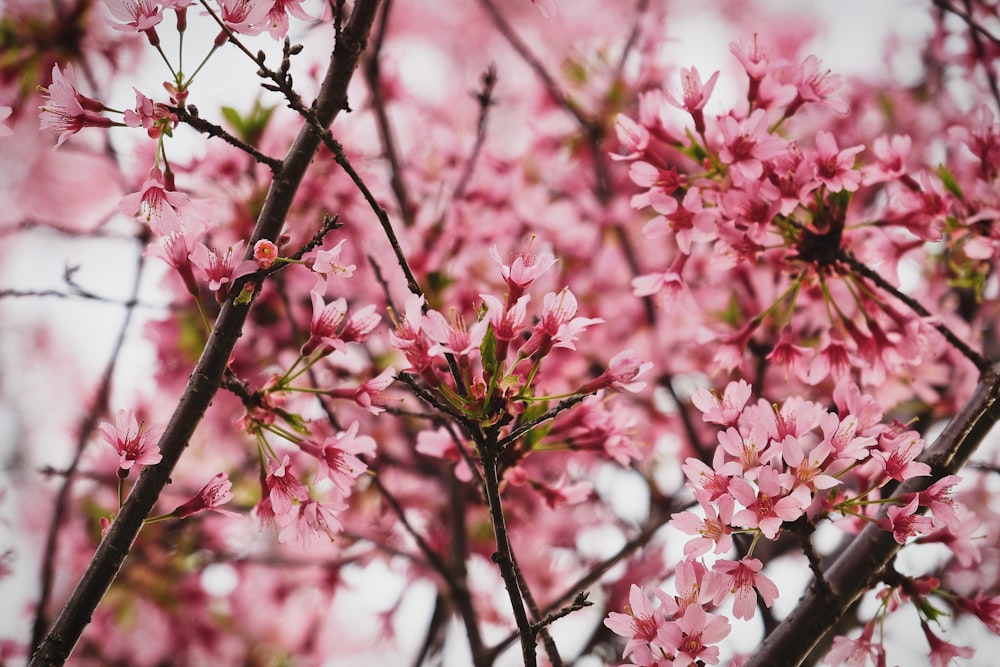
[{"x1": 747, "y1": 364, "x2": 1000, "y2": 667}]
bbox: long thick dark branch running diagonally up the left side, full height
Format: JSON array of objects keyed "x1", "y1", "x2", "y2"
[{"x1": 30, "y1": 0, "x2": 379, "y2": 667}]
